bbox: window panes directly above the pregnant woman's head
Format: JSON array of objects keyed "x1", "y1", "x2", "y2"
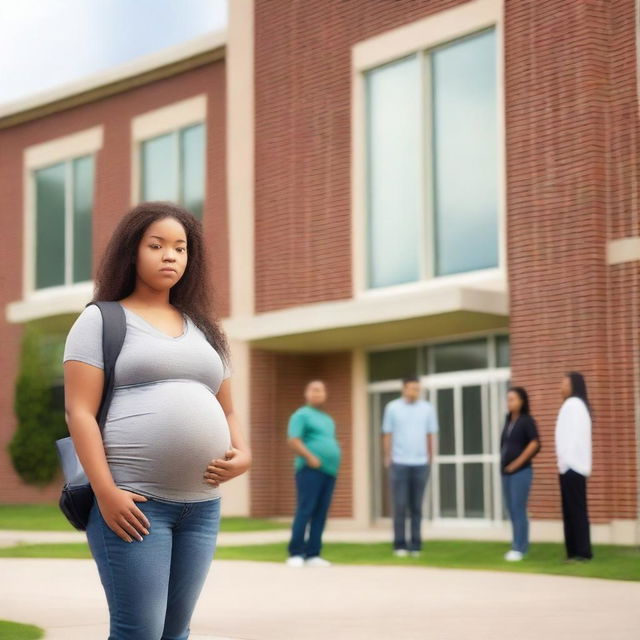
[{"x1": 140, "y1": 124, "x2": 205, "y2": 219}]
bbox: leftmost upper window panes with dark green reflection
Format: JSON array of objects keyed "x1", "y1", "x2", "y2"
[{"x1": 33, "y1": 155, "x2": 94, "y2": 289}]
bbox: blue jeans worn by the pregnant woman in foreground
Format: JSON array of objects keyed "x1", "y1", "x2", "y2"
[{"x1": 87, "y1": 498, "x2": 220, "y2": 640}]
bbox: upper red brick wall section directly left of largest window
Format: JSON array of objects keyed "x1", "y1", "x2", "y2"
[{"x1": 255, "y1": 0, "x2": 462, "y2": 311}]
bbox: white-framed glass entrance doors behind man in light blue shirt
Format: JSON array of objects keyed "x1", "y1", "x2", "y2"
[{"x1": 370, "y1": 369, "x2": 509, "y2": 521}]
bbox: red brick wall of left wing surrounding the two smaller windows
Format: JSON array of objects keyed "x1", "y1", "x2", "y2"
[{"x1": 0, "y1": 61, "x2": 229, "y2": 502}]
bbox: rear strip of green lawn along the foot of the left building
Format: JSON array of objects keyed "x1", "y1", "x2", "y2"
[{"x1": 0, "y1": 504, "x2": 288, "y2": 532}]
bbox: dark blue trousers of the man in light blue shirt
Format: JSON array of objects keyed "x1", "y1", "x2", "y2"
[{"x1": 390, "y1": 462, "x2": 429, "y2": 551}]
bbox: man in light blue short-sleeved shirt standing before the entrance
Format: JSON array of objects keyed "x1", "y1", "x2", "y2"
[{"x1": 382, "y1": 377, "x2": 438, "y2": 556}]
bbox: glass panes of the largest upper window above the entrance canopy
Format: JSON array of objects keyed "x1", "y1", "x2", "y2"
[{"x1": 365, "y1": 29, "x2": 498, "y2": 288}]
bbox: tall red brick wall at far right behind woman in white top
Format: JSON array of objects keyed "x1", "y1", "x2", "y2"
[{"x1": 505, "y1": 0, "x2": 640, "y2": 522}]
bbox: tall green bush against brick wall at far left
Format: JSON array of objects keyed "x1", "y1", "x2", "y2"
[{"x1": 8, "y1": 324, "x2": 69, "y2": 486}]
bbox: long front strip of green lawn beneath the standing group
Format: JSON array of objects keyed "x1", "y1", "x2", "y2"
[{"x1": 0, "y1": 540, "x2": 640, "y2": 581}]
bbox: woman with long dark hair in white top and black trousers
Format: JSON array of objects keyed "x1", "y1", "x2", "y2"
[{"x1": 555, "y1": 371, "x2": 593, "y2": 561}]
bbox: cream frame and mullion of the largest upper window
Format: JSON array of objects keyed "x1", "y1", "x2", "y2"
[{"x1": 351, "y1": 0, "x2": 507, "y2": 298}]
